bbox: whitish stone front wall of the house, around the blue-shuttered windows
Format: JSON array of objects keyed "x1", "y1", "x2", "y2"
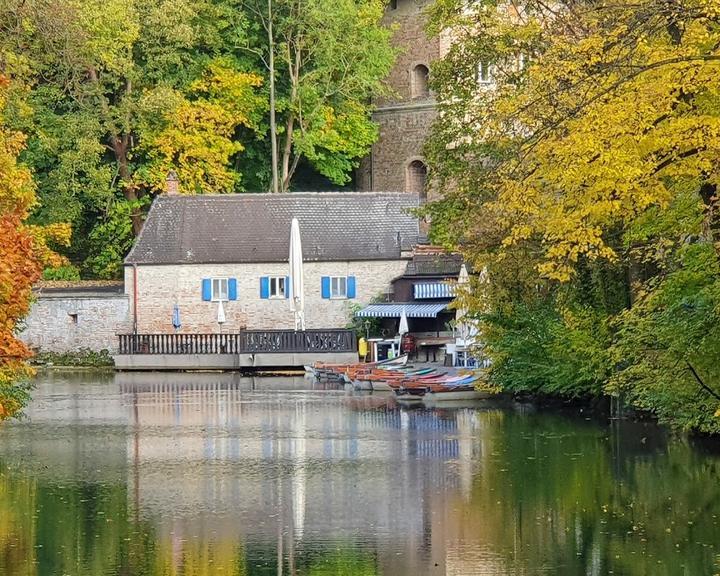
[{"x1": 125, "y1": 260, "x2": 407, "y2": 333}]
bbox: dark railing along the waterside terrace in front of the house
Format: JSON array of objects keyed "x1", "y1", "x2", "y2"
[{"x1": 118, "y1": 330, "x2": 357, "y2": 354}]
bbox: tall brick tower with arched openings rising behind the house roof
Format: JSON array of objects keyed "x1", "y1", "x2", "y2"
[{"x1": 358, "y1": 0, "x2": 442, "y2": 199}]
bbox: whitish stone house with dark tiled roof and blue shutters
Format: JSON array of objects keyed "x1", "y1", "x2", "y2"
[{"x1": 125, "y1": 193, "x2": 420, "y2": 334}]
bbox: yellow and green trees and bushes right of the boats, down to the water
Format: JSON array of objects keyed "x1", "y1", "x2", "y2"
[{"x1": 428, "y1": 0, "x2": 720, "y2": 433}]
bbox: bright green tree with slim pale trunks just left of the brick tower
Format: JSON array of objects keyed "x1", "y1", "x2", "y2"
[{"x1": 244, "y1": 0, "x2": 394, "y2": 192}]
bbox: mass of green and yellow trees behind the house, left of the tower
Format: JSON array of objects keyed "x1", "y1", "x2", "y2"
[{"x1": 0, "y1": 0, "x2": 394, "y2": 278}]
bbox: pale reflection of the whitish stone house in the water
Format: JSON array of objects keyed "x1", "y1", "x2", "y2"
[{"x1": 116, "y1": 376, "x2": 484, "y2": 573}]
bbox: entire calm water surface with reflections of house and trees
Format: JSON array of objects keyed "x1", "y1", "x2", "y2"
[{"x1": 0, "y1": 374, "x2": 720, "y2": 576}]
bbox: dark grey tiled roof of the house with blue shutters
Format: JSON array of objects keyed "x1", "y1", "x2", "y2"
[{"x1": 125, "y1": 192, "x2": 420, "y2": 264}]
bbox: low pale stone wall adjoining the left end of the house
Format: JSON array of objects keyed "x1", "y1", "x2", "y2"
[{"x1": 20, "y1": 292, "x2": 132, "y2": 353}]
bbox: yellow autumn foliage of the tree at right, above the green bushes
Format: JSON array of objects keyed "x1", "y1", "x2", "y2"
[{"x1": 435, "y1": 0, "x2": 720, "y2": 281}]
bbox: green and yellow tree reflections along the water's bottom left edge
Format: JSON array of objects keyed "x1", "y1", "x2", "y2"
[{"x1": 0, "y1": 464, "x2": 377, "y2": 576}]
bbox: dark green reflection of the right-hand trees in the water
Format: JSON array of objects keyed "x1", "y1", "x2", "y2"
[{"x1": 458, "y1": 414, "x2": 720, "y2": 576}]
